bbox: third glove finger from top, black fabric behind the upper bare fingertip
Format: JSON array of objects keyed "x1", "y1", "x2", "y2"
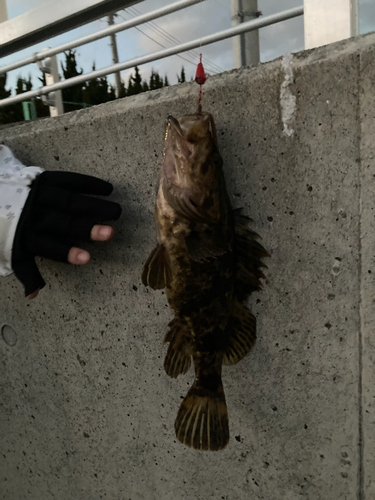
[{"x1": 34, "y1": 210, "x2": 96, "y2": 241}]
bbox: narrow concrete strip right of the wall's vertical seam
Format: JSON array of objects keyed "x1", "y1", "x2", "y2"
[{"x1": 359, "y1": 40, "x2": 375, "y2": 499}]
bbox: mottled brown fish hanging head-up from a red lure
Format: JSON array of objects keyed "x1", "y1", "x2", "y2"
[{"x1": 142, "y1": 107, "x2": 269, "y2": 451}]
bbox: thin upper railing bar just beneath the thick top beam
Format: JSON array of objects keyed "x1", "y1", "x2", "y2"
[{"x1": 0, "y1": 0, "x2": 205, "y2": 75}]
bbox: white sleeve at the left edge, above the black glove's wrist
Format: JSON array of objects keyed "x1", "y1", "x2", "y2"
[{"x1": 0, "y1": 145, "x2": 43, "y2": 276}]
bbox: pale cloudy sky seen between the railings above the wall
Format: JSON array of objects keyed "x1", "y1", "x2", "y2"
[{"x1": 0, "y1": 0, "x2": 375, "y2": 95}]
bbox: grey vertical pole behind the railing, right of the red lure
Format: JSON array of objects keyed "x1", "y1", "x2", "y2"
[{"x1": 231, "y1": 0, "x2": 261, "y2": 68}]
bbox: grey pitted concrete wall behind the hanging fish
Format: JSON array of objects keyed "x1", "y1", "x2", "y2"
[{"x1": 0, "y1": 34, "x2": 375, "y2": 500}]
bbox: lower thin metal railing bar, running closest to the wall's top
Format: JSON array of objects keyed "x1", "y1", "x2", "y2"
[{"x1": 0, "y1": 7, "x2": 303, "y2": 107}]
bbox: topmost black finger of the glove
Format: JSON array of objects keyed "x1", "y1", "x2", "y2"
[{"x1": 40, "y1": 171, "x2": 113, "y2": 196}]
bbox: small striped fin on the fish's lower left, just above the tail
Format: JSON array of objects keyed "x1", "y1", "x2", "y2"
[{"x1": 164, "y1": 319, "x2": 191, "y2": 378}]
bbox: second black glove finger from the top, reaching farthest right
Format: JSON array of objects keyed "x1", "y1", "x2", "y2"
[{"x1": 36, "y1": 187, "x2": 121, "y2": 221}]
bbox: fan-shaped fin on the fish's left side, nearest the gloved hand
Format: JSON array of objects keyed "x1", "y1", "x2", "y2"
[{"x1": 142, "y1": 245, "x2": 172, "y2": 290}]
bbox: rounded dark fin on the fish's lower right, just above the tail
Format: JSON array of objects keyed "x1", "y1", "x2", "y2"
[{"x1": 223, "y1": 301, "x2": 256, "y2": 365}]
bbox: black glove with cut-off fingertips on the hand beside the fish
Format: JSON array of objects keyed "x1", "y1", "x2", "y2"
[{"x1": 12, "y1": 172, "x2": 121, "y2": 296}]
